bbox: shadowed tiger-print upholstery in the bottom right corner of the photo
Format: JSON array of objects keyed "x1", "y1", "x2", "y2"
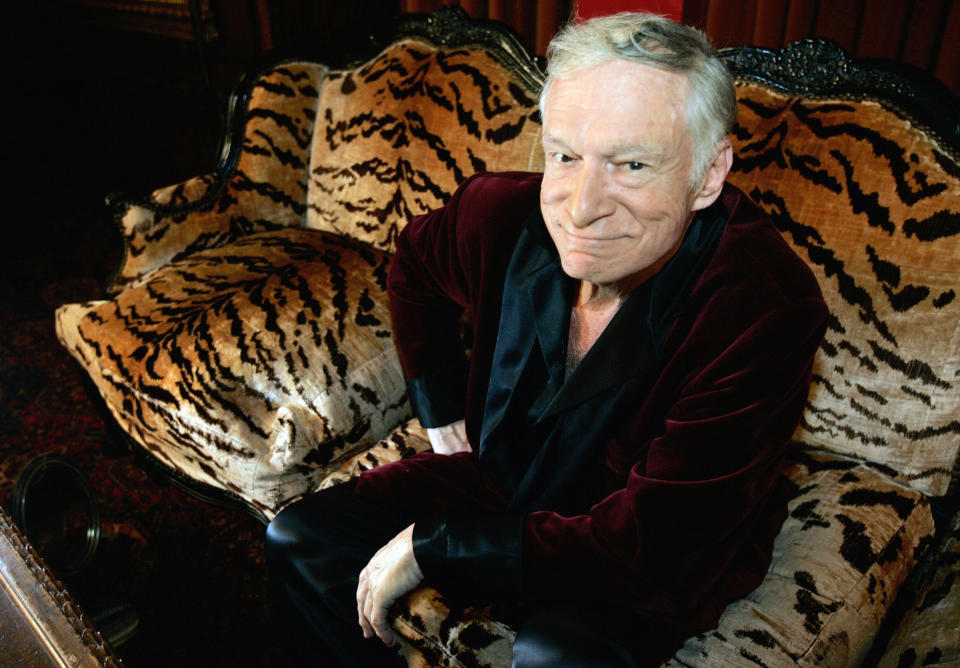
[{"x1": 879, "y1": 513, "x2": 960, "y2": 668}]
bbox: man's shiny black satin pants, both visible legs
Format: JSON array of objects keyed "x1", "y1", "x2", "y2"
[{"x1": 266, "y1": 482, "x2": 684, "y2": 668}]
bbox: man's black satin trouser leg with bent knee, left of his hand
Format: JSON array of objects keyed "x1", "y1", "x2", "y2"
[{"x1": 266, "y1": 483, "x2": 410, "y2": 666}]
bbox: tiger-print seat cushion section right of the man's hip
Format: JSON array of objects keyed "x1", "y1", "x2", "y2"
[{"x1": 666, "y1": 450, "x2": 933, "y2": 668}]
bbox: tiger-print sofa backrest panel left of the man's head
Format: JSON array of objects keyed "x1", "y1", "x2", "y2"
[{"x1": 306, "y1": 37, "x2": 543, "y2": 251}]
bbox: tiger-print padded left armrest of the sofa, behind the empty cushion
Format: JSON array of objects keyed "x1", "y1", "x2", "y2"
[{"x1": 107, "y1": 61, "x2": 327, "y2": 294}]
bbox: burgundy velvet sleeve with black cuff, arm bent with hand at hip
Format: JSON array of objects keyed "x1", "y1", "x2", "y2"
[{"x1": 387, "y1": 173, "x2": 540, "y2": 428}]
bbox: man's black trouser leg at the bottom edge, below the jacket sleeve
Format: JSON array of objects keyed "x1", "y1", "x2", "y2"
[{"x1": 513, "y1": 603, "x2": 686, "y2": 668}]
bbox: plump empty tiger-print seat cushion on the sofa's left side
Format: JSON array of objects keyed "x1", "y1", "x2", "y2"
[{"x1": 57, "y1": 228, "x2": 410, "y2": 518}]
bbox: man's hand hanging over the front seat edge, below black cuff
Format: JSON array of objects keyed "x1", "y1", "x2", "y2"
[{"x1": 357, "y1": 524, "x2": 423, "y2": 646}]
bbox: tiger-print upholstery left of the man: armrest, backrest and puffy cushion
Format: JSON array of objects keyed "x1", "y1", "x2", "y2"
[{"x1": 56, "y1": 24, "x2": 542, "y2": 518}]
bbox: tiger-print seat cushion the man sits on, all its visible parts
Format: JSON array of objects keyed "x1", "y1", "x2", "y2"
[{"x1": 348, "y1": 444, "x2": 933, "y2": 668}]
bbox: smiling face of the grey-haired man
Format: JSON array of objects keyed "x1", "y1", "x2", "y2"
[{"x1": 540, "y1": 60, "x2": 712, "y2": 292}]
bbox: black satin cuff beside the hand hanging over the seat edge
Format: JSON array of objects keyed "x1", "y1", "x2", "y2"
[{"x1": 413, "y1": 513, "x2": 524, "y2": 603}]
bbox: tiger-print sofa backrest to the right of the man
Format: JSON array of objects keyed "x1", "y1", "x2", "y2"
[{"x1": 730, "y1": 83, "x2": 960, "y2": 495}]
